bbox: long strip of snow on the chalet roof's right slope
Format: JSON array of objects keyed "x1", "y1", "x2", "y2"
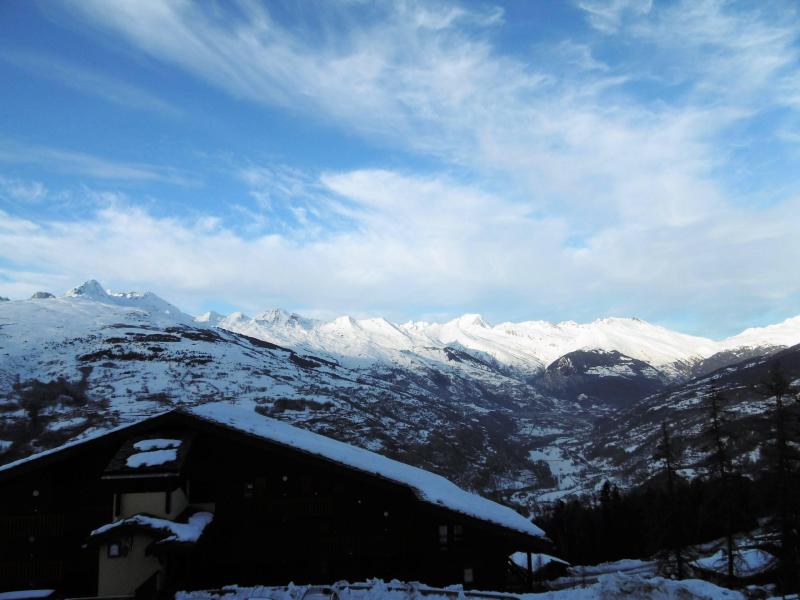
[{"x1": 187, "y1": 403, "x2": 545, "y2": 538}]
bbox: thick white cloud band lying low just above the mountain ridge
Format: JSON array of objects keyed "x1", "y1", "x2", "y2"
[{"x1": 0, "y1": 171, "x2": 800, "y2": 334}]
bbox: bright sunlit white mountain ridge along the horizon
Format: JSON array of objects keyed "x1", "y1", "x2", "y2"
[{"x1": 208, "y1": 309, "x2": 800, "y2": 380}]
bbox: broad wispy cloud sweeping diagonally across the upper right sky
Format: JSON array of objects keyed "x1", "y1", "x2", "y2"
[{"x1": 61, "y1": 0, "x2": 800, "y2": 218}]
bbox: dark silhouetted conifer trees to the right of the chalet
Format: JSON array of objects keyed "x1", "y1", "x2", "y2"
[{"x1": 537, "y1": 363, "x2": 800, "y2": 592}]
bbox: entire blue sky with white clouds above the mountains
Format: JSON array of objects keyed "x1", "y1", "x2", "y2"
[{"x1": 0, "y1": 0, "x2": 800, "y2": 337}]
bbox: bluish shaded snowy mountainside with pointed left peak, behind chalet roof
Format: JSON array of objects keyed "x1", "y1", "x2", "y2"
[{"x1": 0, "y1": 285, "x2": 590, "y2": 502}]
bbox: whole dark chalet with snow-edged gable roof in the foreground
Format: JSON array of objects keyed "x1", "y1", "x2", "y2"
[{"x1": 0, "y1": 403, "x2": 548, "y2": 597}]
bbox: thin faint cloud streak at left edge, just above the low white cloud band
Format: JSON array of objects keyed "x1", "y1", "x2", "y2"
[{"x1": 0, "y1": 137, "x2": 197, "y2": 186}]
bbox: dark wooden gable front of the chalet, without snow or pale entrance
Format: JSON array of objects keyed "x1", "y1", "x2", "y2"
[{"x1": 0, "y1": 412, "x2": 542, "y2": 596}]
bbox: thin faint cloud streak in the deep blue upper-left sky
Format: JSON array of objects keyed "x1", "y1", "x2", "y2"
[{"x1": 0, "y1": 50, "x2": 181, "y2": 117}]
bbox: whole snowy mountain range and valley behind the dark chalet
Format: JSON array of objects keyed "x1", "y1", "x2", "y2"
[{"x1": 0, "y1": 281, "x2": 800, "y2": 507}]
